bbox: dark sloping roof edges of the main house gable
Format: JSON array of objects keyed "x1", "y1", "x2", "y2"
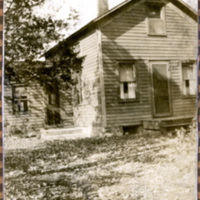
[{"x1": 44, "y1": 0, "x2": 198, "y2": 57}]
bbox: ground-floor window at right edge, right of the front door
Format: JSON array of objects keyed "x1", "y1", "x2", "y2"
[{"x1": 182, "y1": 63, "x2": 197, "y2": 95}]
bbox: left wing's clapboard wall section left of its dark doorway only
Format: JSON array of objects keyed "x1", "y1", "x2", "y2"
[{"x1": 4, "y1": 84, "x2": 45, "y2": 134}]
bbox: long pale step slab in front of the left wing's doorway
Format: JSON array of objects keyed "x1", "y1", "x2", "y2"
[{"x1": 40, "y1": 127, "x2": 91, "y2": 140}]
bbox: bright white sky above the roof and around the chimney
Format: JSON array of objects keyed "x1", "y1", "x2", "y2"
[{"x1": 36, "y1": 0, "x2": 197, "y2": 35}]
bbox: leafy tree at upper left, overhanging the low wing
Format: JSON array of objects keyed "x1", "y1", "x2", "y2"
[{"x1": 5, "y1": 0, "x2": 83, "y2": 89}]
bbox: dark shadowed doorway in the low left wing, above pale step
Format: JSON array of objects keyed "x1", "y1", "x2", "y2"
[{"x1": 46, "y1": 87, "x2": 61, "y2": 125}]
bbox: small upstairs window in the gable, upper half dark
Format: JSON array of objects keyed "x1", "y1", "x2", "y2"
[{"x1": 147, "y1": 4, "x2": 166, "y2": 35}]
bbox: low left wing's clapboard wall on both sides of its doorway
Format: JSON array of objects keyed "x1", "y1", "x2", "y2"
[{"x1": 4, "y1": 84, "x2": 73, "y2": 134}]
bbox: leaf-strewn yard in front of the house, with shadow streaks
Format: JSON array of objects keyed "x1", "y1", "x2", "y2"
[{"x1": 5, "y1": 128, "x2": 197, "y2": 200}]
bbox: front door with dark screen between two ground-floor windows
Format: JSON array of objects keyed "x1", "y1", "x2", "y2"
[{"x1": 151, "y1": 62, "x2": 171, "y2": 117}]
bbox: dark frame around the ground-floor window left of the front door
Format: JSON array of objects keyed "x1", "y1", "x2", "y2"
[{"x1": 117, "y1": 60, "x2": 139, "y2": 103}]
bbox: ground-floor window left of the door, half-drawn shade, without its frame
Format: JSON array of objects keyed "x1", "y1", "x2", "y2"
[{"x1": 119, "y1": 64, "x2": 137, "y2": 99}]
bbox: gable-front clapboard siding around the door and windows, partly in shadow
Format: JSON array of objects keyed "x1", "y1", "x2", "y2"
[{"x1": 101, "y1": 0, "x2": 197, "y2": 126}]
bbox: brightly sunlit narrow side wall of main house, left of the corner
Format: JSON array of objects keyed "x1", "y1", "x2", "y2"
[{"x1": 74, "y1": 31, "x2": 102, "y2": 134}]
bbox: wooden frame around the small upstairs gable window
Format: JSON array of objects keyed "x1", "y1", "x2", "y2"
[{"x1": 146, "y1": 2, "x2": 167, "y2": 37}]
